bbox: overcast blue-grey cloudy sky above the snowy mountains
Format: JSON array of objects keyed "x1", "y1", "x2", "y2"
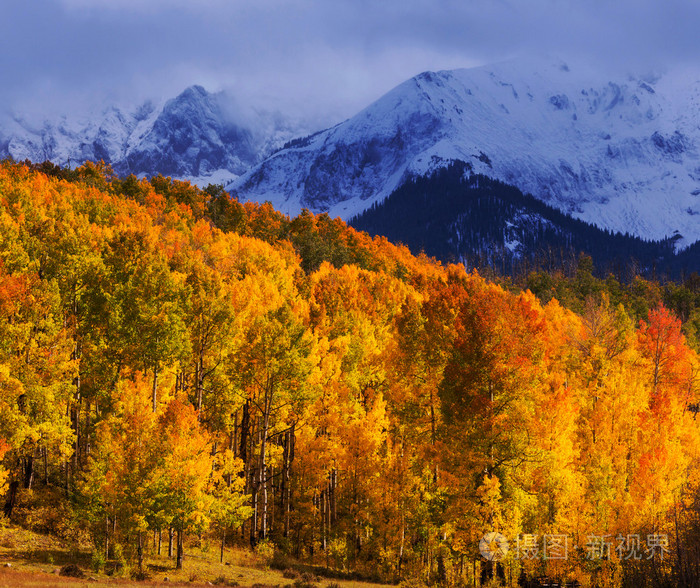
[{"x1": 0, "y1": 0, "x2": 700, "y2": 123}]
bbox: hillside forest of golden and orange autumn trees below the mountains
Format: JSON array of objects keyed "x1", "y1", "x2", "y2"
[{"x1": 0, "y1": 157, "x2": 700, "y2": 587}]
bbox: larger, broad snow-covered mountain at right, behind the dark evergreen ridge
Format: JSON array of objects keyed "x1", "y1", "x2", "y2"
[{"x1": 229, "y1": 62, "x2": 700, "y2": 246}]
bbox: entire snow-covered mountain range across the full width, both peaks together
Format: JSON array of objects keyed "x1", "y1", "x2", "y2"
[{"x1": 0, "y1": 61, "x2": 700, "y2": 247}]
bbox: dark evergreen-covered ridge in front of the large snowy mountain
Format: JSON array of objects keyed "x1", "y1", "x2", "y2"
[{"x1": 350, "y1": 162, "x2": 700, "y2": 281}]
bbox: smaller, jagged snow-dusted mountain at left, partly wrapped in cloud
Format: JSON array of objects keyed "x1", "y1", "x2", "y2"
[{"x1": 0, "y1": 86, "x2": 308, "y2": 184}]
